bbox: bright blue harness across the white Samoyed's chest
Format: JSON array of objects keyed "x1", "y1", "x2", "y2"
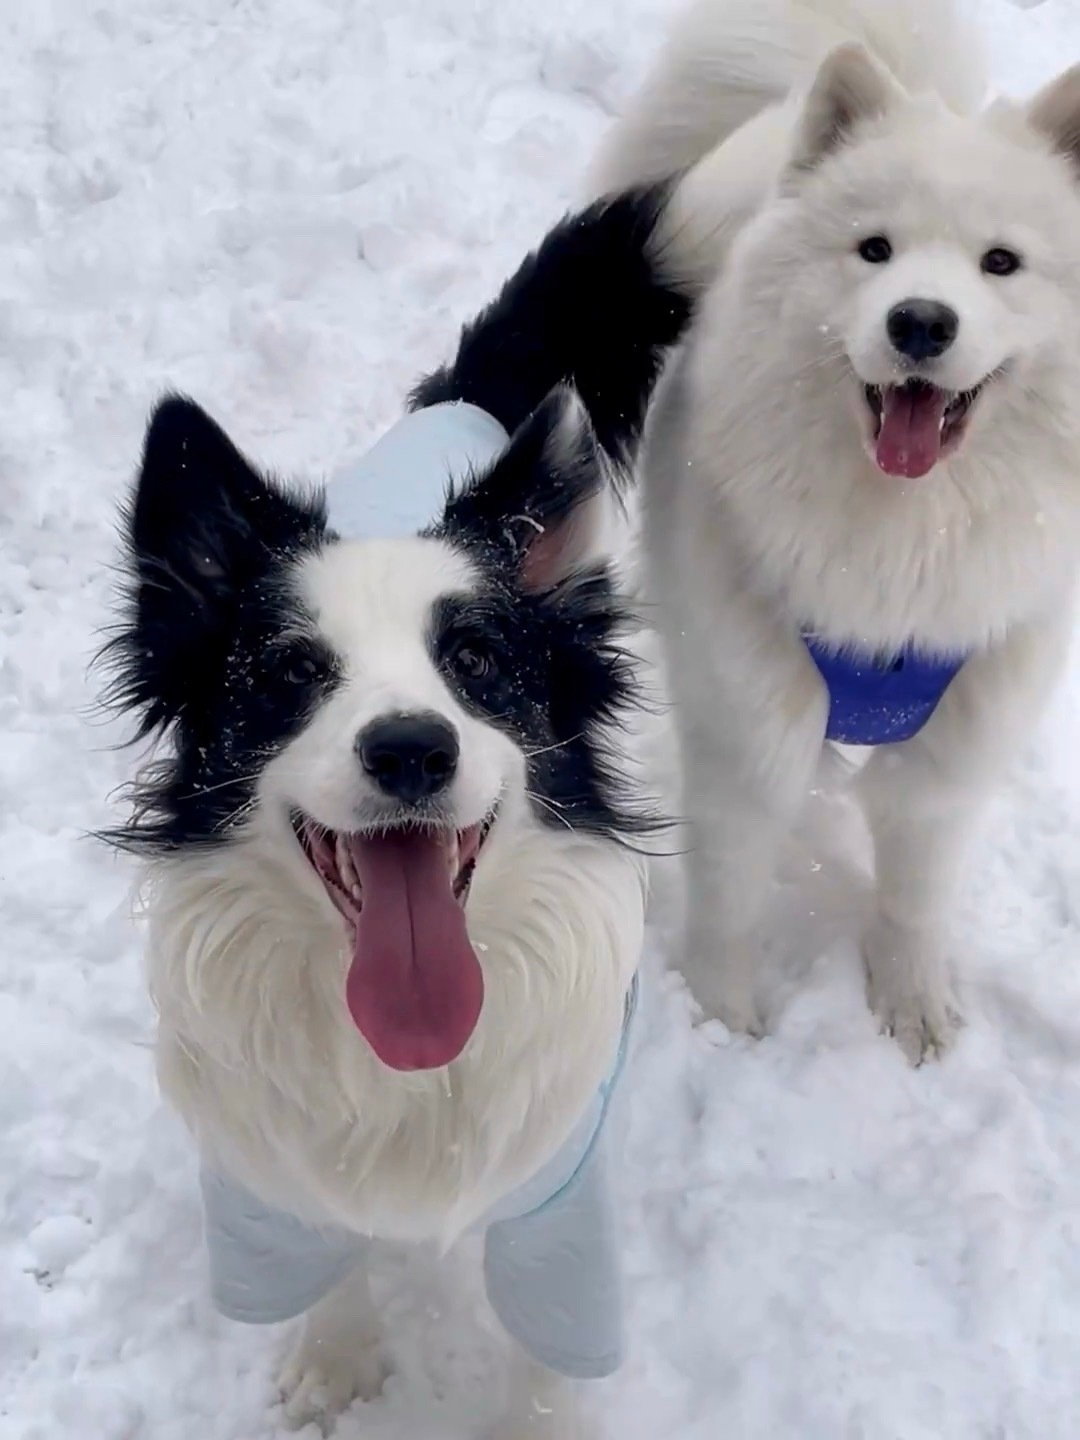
[{"x1": 804, "y1": 635, "x2": 968, "y2": 744}]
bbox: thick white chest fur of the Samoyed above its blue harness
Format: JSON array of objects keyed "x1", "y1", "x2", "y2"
[{"x1": 659, "y1": 331, "x2": 1080, "y2": 651}]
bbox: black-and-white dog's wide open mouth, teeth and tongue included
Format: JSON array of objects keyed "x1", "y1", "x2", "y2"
[{"x1": 294, "y1": 814, "x2": 495, "y2": 1070}]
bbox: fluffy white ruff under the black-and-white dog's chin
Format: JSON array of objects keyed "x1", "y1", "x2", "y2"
[{"x1": 148, "y1": 815, "x2": 644, "y2": 1244}]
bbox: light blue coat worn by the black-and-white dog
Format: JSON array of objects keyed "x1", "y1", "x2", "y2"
[{"x1": 202, "y1": 405, "x2": 636, "y2": 1380}]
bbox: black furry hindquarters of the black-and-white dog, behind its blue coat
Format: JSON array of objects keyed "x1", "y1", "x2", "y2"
[{"x1": 410, "y1": 184, "x2": 691, "y2": 459}]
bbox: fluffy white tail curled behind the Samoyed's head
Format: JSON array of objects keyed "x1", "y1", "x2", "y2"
[{"x1": 589, "y1": 0, "x2": 985, "y2": 194}]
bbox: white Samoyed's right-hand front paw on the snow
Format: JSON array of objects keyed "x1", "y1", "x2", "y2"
[{"x1": 864, "y1": 922, "x2": 960, "y2": 1066}]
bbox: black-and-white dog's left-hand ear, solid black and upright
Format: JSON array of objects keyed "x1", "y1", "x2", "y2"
[{"x1": 109, "y1": 396, "x2": 325, "y2": 734}]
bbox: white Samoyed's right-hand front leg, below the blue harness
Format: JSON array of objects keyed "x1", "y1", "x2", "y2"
[{"x1": 860, "y1": 613, "x2": 1067, "y2": 1064}]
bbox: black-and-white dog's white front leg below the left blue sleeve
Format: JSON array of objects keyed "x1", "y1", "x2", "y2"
[{"x1": 278, "y1": 1263, "x2": 386, "y2": 1428}]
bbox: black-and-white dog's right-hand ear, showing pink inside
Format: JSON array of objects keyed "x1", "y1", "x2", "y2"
[{"x1": 438, "y1": 384, "x2": 609, "y2": 590}]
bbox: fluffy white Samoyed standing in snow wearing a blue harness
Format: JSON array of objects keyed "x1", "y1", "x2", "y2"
[{"x1": 593, "y1": 0, "x2": 1080, "y2": 1061}]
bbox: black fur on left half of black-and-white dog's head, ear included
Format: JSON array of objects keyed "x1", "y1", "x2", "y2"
[{"x1": 104, "y1": 396, "x2": 333, "y2": 851}]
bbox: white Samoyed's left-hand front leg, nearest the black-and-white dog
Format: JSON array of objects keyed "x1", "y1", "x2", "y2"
[{"x1": 672, "y1": 636, "x2": 827, "y2": 1034}]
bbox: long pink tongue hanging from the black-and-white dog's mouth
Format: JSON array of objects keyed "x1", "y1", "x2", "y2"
[{"x1": 346, "y1": 831, "x2": 484, "y2": 1070}]
